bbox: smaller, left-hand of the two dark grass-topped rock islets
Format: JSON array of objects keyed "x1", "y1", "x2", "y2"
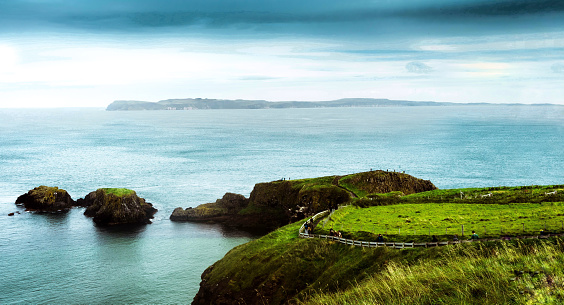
[{"x1": 16, "y1": 185, "x2": 75, "y2": 213}]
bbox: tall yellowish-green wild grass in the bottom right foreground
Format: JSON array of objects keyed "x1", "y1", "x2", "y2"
[{"x1": 301, "y1": 239, "x2": 564, "y2": 305}]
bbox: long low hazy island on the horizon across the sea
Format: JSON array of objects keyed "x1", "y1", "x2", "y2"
[{"x1": 106, "y1": 98, "x2": 468, "y2": 111}]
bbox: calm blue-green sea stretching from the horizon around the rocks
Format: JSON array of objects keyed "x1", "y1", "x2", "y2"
[{"x1": 0, "y1": 106, "x2": 564, "y2": 304}]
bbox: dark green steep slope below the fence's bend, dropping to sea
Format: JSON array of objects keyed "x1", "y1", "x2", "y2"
[{"x1": 200, "y1": 222, "x2": 448, "y2": 304}]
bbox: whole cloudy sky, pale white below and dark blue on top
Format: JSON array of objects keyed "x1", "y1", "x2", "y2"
[{"x1": 0, "y1": 0, "x2": 564, "y2": 108}]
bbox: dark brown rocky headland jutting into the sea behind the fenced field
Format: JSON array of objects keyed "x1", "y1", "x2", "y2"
[{"x1": 170, "y1": 171, "x2": 436, "y2": 231}]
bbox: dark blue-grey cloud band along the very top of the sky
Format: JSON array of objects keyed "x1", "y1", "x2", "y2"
[{"x1": 0, "y1": 0, "x2": 564, "y2": 36}]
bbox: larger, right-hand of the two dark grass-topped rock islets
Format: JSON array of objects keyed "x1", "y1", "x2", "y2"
[{"x1": 80, "y1": 188, "x2": 157, "y2": 225}]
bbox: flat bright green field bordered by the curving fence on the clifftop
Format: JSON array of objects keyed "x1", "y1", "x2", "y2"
[{"x1": 315, "y1": 202, "x2": 564, "y2": 242}]
